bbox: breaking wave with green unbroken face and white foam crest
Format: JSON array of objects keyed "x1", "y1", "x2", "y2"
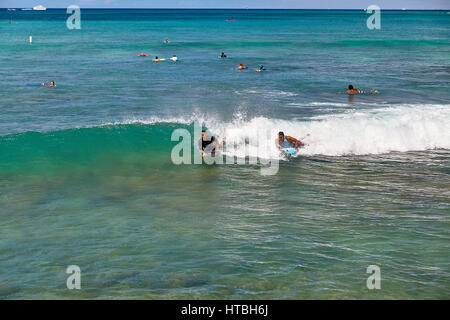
[{"x1": 0, "y1": 104, "x2": 450, "y2": 159}]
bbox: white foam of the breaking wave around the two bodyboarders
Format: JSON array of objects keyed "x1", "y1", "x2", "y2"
[{"x1": 107, "y1": 104, "x2": 450, "y2": 158}]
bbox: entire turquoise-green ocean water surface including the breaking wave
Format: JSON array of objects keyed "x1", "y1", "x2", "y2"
[{"x1": 0, "y1": 9, "x2": 450, "y2": 299}]
